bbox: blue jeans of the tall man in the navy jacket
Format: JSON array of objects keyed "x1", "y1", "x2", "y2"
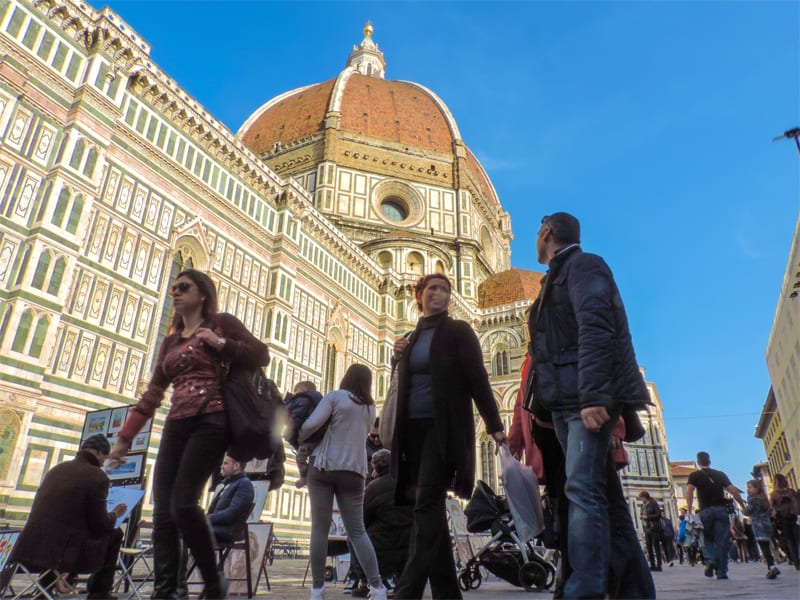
[{"x1": 553, "y1": 411, "x2": 655, "y2": 598}]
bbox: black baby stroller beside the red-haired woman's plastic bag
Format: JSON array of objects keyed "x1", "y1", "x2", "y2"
[{"x1": 458, "y1": 481, "x2": 558, "y2": 592}]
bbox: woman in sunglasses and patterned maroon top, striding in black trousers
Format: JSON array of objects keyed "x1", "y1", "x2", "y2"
[{"x1": 111, "y1": 269, "x2": 269, "y2": 598}]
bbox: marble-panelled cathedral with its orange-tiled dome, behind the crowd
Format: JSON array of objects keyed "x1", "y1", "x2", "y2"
[{"x1": 0, "y1": 0, "x2": 668, "y2": 538}]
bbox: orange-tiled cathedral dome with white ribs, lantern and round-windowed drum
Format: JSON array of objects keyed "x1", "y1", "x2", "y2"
[{"x1": 237, "y1": 24, "x2": 513, "y2": 288}]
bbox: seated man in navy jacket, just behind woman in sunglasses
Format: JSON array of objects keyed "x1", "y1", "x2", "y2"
[{"x1": 208, "y1": 455, "x2": 255, "y2": 544}]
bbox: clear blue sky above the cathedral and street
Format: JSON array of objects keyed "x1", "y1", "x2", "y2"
[{"x1": 103, "y1": 0, "x2": 800, "y2": 488}]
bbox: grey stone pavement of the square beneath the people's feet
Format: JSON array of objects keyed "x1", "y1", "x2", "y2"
[{"x1": 3, "y1": 558, "x2": 800, "y2": 600}]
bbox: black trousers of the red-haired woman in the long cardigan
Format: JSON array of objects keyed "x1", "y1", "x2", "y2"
[{"x1": 394, "y1": 419, "x2": 462, "y2": 600}]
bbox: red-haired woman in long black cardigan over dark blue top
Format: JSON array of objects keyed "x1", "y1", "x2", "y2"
[{"x1": 382, "y1": 273, "x2": 506, "y2": 599}]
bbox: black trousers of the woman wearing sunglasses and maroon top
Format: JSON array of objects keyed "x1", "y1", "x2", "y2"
[{"x1": 153, "y1": 413, "x2": 228, "y2": 598}]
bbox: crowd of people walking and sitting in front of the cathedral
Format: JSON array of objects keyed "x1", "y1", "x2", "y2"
[{"x1": 3, "y1": 217, "x2": 800, "y2": 600}]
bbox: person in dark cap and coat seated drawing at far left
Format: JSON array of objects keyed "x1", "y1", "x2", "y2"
[{"x1": 9, "y1": 434, "x2": 127, "y2": 598}]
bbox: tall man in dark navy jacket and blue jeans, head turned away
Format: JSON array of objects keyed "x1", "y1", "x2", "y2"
[{"x1": 528, "y1": 212, "x2": 655, "y2": 598}]
